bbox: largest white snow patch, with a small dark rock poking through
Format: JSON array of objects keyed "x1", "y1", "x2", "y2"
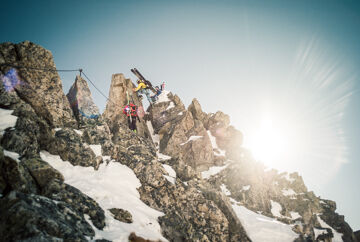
[{"x1": 40, "y1": 151, "x2": 167, "y2": 241}]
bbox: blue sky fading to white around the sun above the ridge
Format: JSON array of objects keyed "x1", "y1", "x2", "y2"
[{"x1": 0, "y1": 0, "x2": 360, "y2": 230}]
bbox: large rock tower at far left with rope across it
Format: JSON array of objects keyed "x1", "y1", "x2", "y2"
[{"x1": 0, "y1": 41, "x2": 76, "y2": 127}]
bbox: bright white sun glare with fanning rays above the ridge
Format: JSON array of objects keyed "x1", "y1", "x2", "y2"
[{"x1": 246, "y1": 37, "x2": 356, "y2": 188}]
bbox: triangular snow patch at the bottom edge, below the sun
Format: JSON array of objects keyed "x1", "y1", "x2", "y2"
[{"x1": 230, "y1": 198, "x2": 298, "y2": 242}]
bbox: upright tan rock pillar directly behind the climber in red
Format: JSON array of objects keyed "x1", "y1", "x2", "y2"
[{"x1": 103, "y1": 74, "x2": 150, "y2": 139}]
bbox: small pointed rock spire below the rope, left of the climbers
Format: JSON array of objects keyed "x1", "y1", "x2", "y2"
[{"x1": 66, "y1": 76, "x2": 101, "y2": 126}]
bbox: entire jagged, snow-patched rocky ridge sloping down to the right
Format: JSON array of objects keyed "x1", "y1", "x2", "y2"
[{"x1": 0, "y1": 42, "x2": 358, "y2": 241}]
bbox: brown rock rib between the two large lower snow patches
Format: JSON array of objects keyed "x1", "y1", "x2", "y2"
[{"x1": 116, "y1": 117, "x2": 246, "y2": 241}]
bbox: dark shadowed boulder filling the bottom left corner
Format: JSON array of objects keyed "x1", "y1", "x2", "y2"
[{"x1": 0, "y1": 191, "x2": 95, "y2": 241}]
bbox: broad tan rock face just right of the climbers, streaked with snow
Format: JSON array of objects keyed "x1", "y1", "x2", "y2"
[{"x1": 149, "y1": 93, "x2": 215, "y2": 171}]
